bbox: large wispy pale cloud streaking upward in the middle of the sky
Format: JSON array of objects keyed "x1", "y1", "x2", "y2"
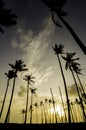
[{"x1": 12, "y1": 17, "x2": 55, "y2": 86}]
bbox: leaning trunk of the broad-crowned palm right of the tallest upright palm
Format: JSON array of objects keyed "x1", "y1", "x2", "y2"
[{"x1": 70, "y1": 67, "x2": 86, "y2": 122}]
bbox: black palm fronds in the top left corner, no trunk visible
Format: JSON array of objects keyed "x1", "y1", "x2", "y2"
[{"x1": 0, "y1": 0, "x2": 18, "y2": 33}]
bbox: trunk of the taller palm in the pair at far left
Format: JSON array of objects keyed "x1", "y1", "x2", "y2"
[{"x1": 4, "y1": 77, "x2": 16, "y2": 123}]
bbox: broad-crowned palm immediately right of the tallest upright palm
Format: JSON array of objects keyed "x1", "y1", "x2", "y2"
[{"x1": 62, "y1": 53, "x2": 86, "y2": 122}]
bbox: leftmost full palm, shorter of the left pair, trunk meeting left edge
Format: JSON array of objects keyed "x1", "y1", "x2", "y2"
[{"x1": 0, "y1": 70, "x2": 14, "y2": 118}]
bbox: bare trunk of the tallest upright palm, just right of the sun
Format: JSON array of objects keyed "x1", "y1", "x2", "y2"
[{"x1": 57, "y1": 55, "x2": 71, "y2": 123}]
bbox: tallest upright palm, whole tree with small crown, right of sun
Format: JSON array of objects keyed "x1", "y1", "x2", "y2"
[{"x1": 53, "y1": 44, "x2": 71, "y2": 123}]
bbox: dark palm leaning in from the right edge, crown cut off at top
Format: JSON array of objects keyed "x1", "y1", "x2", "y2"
[{"x1": 42, "y1": 0, "x2": 86, "y2": 55}]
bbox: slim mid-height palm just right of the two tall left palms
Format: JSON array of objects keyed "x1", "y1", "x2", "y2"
[{"x1": 24, "y1": 75, "x2": 34, "y2": 124}]
